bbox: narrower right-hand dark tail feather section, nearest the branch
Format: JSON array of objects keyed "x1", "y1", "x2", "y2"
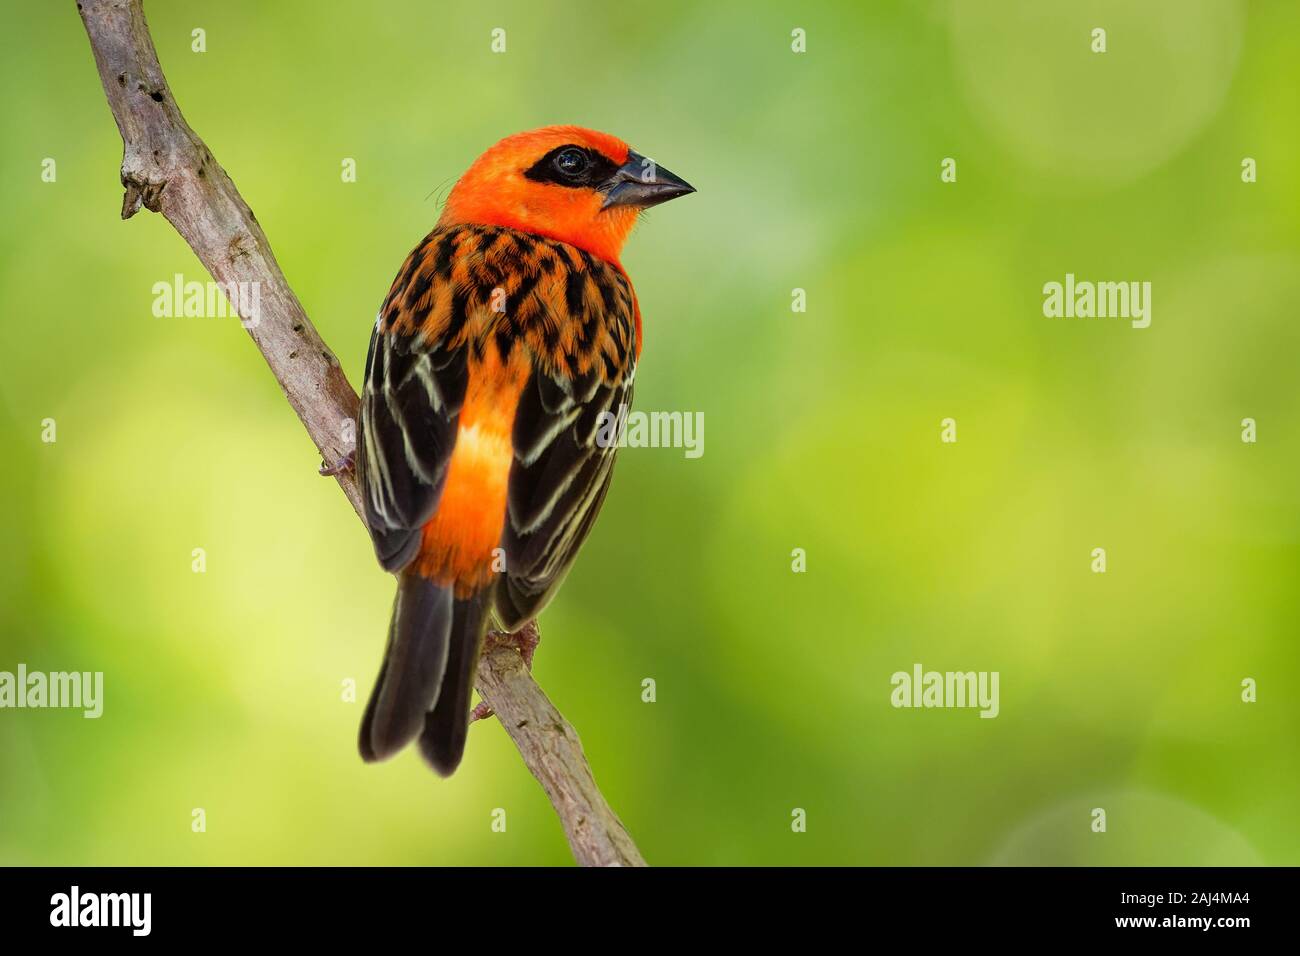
[{"x1": 420, "y1": 588, "x2": 491, "y2": 777}]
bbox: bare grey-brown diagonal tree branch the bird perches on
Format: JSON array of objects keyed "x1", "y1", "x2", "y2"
[{"x1": 77, "y1": 0, "x2": 645, "y2": 866}]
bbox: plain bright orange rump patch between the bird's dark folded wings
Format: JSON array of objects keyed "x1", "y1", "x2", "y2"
[{"x1": 416, "y1": 341, "x2": 528, "y2": 597}]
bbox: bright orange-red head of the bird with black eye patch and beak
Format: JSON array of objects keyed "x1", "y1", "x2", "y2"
[{"x1": 438, "y1": 126, "x2": 696, "y2": 264}]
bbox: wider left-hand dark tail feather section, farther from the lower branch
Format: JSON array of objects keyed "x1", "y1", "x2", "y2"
[{"x1": 360, "y1": 571, "x2": 459, "y2": 761}]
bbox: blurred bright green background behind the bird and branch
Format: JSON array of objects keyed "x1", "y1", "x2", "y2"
[{"x1": 0, "y1": 0, "x2": 1300, "y2": 865}]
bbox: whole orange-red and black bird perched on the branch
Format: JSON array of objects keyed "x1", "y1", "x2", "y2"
[{"x1": 356, "y1": 126, "x2": 694, "y2": 777}]
